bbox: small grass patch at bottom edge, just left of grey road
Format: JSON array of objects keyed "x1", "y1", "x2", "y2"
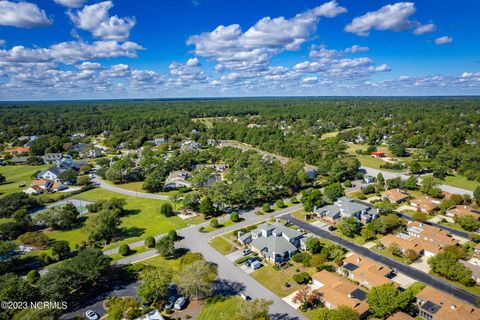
[{"x1": 197, "y1": 296, "x2": 241, "y2": 320}]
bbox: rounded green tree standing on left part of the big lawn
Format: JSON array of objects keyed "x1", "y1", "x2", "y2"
[{"x1": 85, "y1": 211, "x2": 120, "y2": 243}]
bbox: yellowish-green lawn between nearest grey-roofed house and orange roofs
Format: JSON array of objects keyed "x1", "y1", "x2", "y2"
[{"x1": 251, "y1": 265, "x2": 315, "y2": 298}]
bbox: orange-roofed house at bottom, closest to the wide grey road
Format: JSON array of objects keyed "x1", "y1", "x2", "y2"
[{"x1": 312, "y1": 270, "x2": 368, "y2": 319}]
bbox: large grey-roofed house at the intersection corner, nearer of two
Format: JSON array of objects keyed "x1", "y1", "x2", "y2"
[{"x1": 238, "y1": 222, "x2": 303, "y2": 263}]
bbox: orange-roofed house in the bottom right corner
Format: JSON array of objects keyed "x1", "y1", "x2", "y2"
[{"x1": 417, "y1": 286, "x2": 480, "y2": 320}]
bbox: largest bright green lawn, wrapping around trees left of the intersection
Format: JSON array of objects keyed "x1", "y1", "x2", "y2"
[{"x1": 44, "y1": 188, "x2": 202, "y2": 249}]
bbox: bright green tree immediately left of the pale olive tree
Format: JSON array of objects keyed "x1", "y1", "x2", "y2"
[{"x1": 137, "y1": 267, "x2": 173, "y2": 305}]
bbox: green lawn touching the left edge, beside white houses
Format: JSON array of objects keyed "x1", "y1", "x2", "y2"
[{"x1": 0, "y1": 165, "x2": 50, "y2": 196}]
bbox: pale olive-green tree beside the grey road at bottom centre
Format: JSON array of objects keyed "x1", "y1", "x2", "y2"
[{"x1": 176, "y1": 260, "x2": 218, "y2": 299}]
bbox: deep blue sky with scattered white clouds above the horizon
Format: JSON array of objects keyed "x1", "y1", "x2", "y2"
[{"x1": 0, "y1": 0, "x2": 480, "y2": 100}]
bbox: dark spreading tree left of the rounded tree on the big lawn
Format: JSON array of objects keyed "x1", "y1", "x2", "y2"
[{"x1": 35, "y1": 203, "x2": 80, "y2": 230}]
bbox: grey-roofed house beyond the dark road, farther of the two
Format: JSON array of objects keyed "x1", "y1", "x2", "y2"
[{"x1": 313, "y1": 197, "x2": 380, "y2": 223}]
